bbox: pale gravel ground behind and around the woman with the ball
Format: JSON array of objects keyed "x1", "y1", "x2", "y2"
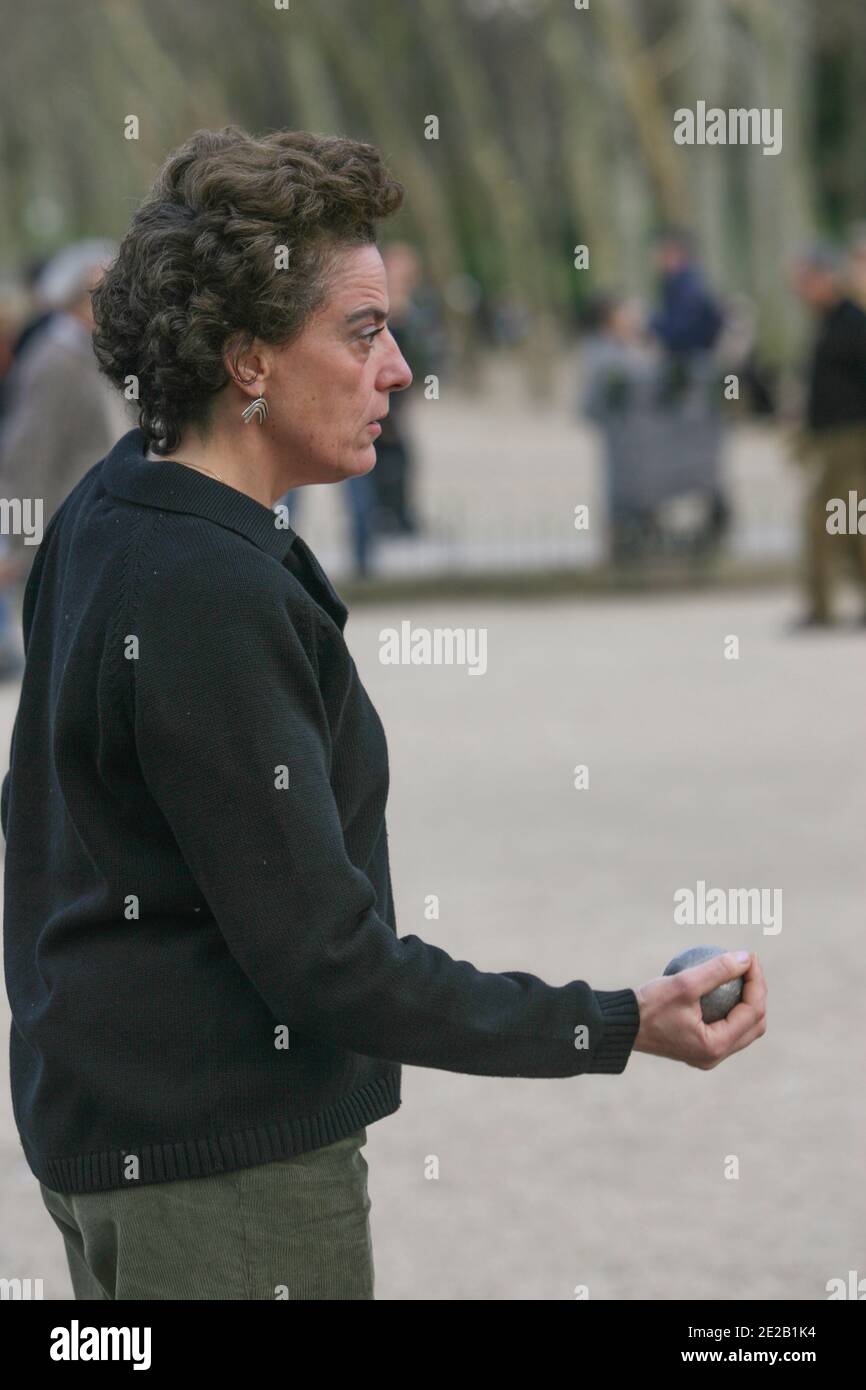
[{"x1": 0, "y1": 581, "x2": 866, "y2": 1300}]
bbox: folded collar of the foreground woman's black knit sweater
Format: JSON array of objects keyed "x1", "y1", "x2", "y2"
[{"x1": 101, "y1": 428, "x2": 299, "y2": 562}]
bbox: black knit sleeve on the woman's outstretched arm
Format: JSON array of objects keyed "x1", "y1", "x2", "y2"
[{"x1": 133, "y1": 566, "x2": 639, "y2": 1077}]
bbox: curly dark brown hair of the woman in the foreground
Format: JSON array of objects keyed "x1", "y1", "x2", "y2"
[{"x1": 93, "y1": 125, "x2": 403, "y2": 455}]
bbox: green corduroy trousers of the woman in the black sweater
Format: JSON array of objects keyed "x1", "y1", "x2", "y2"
[{"x1": 39, "y1": 1129, "x2": 374, "y2": 1300}]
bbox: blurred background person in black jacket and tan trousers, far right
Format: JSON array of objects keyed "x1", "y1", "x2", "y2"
[{"x1": 791, "y1": 242, "x2": 866, "y2": 627}]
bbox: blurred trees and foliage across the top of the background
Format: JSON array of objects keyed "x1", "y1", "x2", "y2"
[{"x1": 0, "y1": 0, "x2": 866, "y2": 379}]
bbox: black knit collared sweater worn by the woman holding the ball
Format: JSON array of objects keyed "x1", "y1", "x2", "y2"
[{"x1": 1, "y1": 430, "x2": 639, "y2": 1193}]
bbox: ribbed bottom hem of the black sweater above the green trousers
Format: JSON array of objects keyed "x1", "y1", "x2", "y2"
[{"x1": 24, "y1": 1072, "x2": 400, "y2": 1193}]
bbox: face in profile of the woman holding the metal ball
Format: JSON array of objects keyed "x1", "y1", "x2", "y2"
[{"x1": 264, "y1": 246, "x2": 411, "y2": 487}]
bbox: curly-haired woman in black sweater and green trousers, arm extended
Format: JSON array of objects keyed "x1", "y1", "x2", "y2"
[{"x1": 3, "y1": 128, "x2": 762, "y2": 1300}]
